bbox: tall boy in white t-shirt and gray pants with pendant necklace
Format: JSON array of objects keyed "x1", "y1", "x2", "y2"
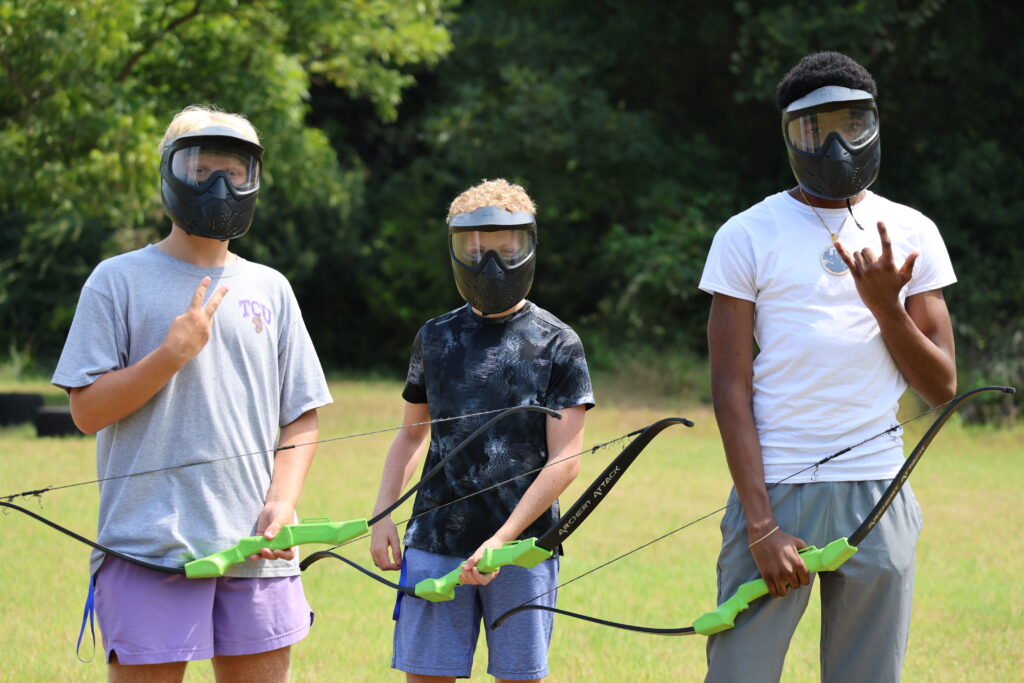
[{"x1": 700, "y1": 52, "x2": 956, "y2": 681}]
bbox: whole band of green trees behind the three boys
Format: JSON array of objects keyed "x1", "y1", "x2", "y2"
[{"x1": 0, "y1": 0, "x2": 1024, "y2": 419}]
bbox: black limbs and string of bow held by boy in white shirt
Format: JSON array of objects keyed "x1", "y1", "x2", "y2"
[{"x1": 490, "y1": 385, "x2": 1017, "y2": 636}]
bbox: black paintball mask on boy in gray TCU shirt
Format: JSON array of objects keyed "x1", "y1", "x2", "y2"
[{"x1": 160, "y1": 126, "x2": 263, "y2": 240}]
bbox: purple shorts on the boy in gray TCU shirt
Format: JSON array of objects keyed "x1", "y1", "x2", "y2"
[{"x1": 95, "y1": 556, "x2": 313, "y2": 665}]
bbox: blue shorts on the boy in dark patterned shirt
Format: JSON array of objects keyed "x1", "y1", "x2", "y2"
[{"x1": 391, "y1": 548, "x2": 558, "y2": 681}]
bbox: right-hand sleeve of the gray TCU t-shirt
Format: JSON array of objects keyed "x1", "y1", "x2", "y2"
[{"x1": 278, "y1": 288, "x2": 334, "y2": 427}]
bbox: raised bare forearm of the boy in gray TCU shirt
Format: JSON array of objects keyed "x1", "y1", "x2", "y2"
[{"x1": 70, "y1": 345, "x2": 184, "y2": 434}]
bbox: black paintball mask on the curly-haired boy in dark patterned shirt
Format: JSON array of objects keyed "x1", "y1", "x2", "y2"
[{"x1": 449, "y1": 206, "x2": 537, "y2": 315}]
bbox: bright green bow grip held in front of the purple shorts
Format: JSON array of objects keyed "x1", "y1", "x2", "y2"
[{"x1": 185, "y1": 517, "x2": 370, "y2": 579}]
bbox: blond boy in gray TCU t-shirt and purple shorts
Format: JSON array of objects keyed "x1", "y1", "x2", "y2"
[{"x1": 53, "y1": 106, "x2": 331, "y2": 681}]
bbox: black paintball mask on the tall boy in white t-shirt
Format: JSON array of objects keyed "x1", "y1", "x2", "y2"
[{"x1": 782, "y1": 85, "x2": 882, "y2": 200}]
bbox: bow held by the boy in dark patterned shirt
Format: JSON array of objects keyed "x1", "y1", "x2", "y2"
[{"x1": 301, "y1": 418, "x2": 693, "y2": 602}]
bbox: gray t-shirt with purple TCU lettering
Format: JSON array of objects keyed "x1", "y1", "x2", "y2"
[{"x1": 52, "y1": 245, "x2": 332, "y2": 578}]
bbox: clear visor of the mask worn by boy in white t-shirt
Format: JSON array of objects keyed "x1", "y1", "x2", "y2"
[{"x1": 785, "y1": 102, "x2": 879, "y2": 154}]
